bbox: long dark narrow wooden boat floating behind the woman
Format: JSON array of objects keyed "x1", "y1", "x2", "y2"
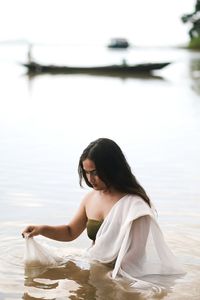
[{"x1": 22, "y1": 61, "x2": 170, "y2": 75}]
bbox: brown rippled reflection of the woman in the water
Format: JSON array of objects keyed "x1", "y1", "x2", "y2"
[{"x1": 23, "y1": 260, "x2": 184, "y2": 300}]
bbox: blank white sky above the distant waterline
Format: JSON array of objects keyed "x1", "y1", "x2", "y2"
[{"x1": 0, "y1": 0, "x2": 196, "y2": 46}]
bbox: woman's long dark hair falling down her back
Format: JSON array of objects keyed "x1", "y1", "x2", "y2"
[{"x1": 78, "y1": 138, "x2": 151, "y2": 206}]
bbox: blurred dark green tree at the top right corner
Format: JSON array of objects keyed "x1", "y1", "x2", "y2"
[{"x1": 181, "y1": 0, "x2": 200, "y2": 40}]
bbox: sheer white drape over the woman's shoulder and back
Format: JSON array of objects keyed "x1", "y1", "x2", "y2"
[{"x1": 89, "y1": 195, "x2": 184, "y2": 279}]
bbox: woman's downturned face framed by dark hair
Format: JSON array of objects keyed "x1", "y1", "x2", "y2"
[{"x1": 83, "y1": 159, "x2": 107, "y2": 191}]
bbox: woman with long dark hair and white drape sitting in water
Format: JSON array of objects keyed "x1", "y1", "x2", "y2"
[{"x1": 22, "y1": 138, "x2": 184, "y2": 287}]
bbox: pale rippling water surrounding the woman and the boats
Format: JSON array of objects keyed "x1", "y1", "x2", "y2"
[{"x1": 0, "y1": 45, "x2": 200, "y2": 300}]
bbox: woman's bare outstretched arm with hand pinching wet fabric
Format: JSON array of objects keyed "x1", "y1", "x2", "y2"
[{"x1": 22, "y1": 199, "x2": 87, "y2": 242}]
